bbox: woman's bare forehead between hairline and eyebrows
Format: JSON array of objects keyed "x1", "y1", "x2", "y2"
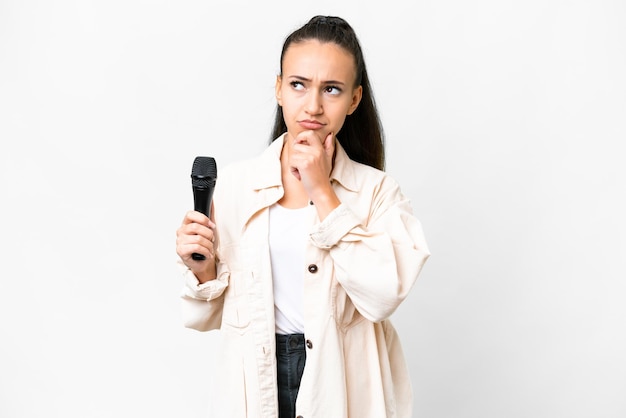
[{"x1": 282, "y1": 40, "x2": 356, "y2": 81}]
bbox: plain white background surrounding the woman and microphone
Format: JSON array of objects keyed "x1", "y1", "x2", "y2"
[{"x1": 0, "y1": 0, "x2": 626, "y2": 418}]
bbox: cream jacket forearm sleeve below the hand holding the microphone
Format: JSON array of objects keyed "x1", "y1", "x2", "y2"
[{"x1": 177, "y1": 260, "x2": 228, "y2": 331}]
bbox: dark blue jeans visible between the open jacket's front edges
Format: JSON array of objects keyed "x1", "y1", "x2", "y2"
[{"x1": 276, "y1": 334, "x2": 306, "y2": 418}]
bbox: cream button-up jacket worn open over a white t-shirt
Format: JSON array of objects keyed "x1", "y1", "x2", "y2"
[{"x1": 180, "y1": 138, "x2": 429, "y2": 418}]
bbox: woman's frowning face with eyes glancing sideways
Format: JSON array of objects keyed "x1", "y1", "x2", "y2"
[{"x1": 276, "y1": 40, "x2": 362, "y2": 139}]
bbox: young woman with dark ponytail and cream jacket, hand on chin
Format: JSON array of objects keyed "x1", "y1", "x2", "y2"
[{"x1": 176, "y1": 16, "x2": 429, "y2": 418}]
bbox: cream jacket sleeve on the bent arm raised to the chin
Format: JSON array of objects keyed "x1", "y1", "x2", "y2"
[{"x1": 310, "y1": 177, "x2": 430, "y2": 322}]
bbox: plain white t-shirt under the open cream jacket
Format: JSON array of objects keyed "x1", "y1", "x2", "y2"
[{"x1": 269, "y1": 203, "x2": 314, "y2": 334}]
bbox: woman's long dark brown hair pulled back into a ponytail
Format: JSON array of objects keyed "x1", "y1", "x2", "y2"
[{"x1": 270, "y1": 16, "x2": 385, "y2": 170}]
